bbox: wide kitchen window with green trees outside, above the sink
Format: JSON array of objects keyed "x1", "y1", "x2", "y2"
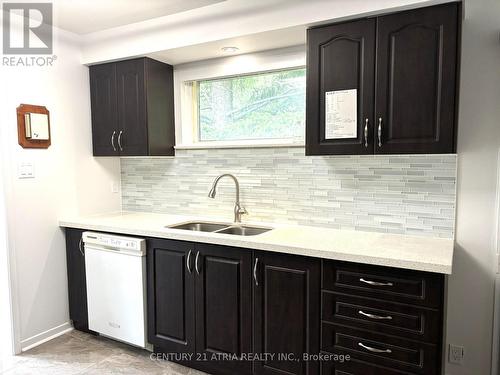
[{"x1": 191, "y1": 68, "x2": 306, "y2": 144}]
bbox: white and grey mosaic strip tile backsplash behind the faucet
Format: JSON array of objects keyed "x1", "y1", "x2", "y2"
[{"x1": 121, "y1": 147, "x2": 456, "y2": 238}]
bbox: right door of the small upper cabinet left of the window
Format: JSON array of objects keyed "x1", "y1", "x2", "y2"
[{"x1": 116, "y1": 59, "x2": 148, "y2": 156}]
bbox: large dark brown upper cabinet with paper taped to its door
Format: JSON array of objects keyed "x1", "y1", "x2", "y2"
[{"x1": 306, "y1": 3, "x2": 461, "y2": 155}]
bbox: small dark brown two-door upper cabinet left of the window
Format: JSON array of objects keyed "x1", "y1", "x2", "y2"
[{"x1": 90, "y1": 58, "x2": 175, "y2": 156}]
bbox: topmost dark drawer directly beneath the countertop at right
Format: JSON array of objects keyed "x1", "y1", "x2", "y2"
[{"x1": 323, "y1": 260, "x2": 444, "y2": 308}]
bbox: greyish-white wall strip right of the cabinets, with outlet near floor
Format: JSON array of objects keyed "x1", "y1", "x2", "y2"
[{"x1": 446, "y1": 0, "x2": 500, "y2": 375}]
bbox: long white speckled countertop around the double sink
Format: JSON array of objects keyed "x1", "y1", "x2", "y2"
[{"x1": 59, "y1": 212, "x2": 454, "y2": 274}]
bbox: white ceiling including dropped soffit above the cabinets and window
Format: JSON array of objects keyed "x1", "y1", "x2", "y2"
[{"x1": 52, "y1": 0, "x2": 450, "y2": 65}]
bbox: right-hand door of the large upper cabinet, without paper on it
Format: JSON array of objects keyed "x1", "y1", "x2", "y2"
[{"x1": 375, "y1": 3, "x2": 459, "y2": 154}]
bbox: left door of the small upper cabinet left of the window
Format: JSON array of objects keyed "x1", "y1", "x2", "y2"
[{"x1": 89, "y1": 64, "x2": 119, "y2": 156}]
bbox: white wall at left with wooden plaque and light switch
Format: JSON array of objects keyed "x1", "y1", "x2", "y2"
[{"x1": 0, "y1": 25, "x2": 121, "y2": 347}]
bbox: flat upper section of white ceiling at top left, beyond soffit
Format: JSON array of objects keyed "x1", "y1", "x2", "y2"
[{"x1": 53, "y1": 0, "x2": 224, "y2": 35}]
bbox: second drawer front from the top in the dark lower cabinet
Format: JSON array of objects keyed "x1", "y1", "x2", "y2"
[{"x1": 322, "y1": 291, "x2": 441, "y2": 344}]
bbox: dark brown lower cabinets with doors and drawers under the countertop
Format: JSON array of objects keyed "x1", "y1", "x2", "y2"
[{"x1": 66, "y1": 229, "x2": 445, "y2": 375}]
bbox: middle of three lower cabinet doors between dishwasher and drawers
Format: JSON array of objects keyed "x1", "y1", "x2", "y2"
[{"x1": 195, "y1": 244, "x2": 252, "y2": 374}]
